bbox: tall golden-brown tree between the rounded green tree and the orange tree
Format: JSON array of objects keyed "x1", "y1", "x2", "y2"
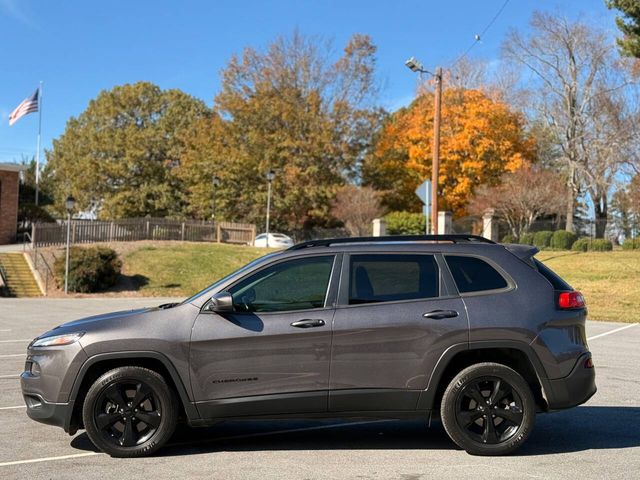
[{"x1": 177, "y1": 32, "x2": 378, "y2": 229}]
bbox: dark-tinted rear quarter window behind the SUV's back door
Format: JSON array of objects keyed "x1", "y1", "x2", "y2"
[{"x1": 445, "y1": 255, "x2": 509, "y2": 293}]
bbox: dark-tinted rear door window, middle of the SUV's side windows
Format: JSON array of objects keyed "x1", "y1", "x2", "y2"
[{"x1": 349, "y1": 254, "x2": 439, "y2": 305}]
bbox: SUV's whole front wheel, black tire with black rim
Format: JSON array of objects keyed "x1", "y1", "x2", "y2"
[{"x1": 82, "y1": 366, "x2": 178, "y2": 457}]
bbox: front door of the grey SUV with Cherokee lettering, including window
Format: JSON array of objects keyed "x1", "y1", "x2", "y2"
[{"x1": 190, "y1": 254, "x2": 340, "y2": 418}]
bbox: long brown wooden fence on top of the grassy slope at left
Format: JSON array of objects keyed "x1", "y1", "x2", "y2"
[{"x1": 31, "y1": 218, "x2": 256, "y2": 247}]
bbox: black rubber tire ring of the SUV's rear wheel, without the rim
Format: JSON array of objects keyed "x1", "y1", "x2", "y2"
[{"x1": 440, "y1": 363, "x2": 536, "y2": 455}]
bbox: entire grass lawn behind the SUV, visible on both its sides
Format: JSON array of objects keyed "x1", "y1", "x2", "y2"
[{"x1": 119, "y1": 242, "x2": 640, "y2": 322}]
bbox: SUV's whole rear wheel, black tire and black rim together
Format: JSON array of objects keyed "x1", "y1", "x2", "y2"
[{"x1": 440, "y1": 363, "x2": 536, "y2": 455}]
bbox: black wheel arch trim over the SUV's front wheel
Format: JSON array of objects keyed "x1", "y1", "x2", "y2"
[{"x1": 65, "y1": 351, "x2": 199, "y2": 435}]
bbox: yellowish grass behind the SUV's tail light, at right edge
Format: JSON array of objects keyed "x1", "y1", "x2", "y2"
[{"x1": 536, "y1": 250, "x2": 640, "y2": 322}]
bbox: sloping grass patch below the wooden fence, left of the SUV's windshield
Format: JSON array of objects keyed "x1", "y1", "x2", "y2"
[{"x1": 121, "y1": 242, "x2": 271, "y2": 297}]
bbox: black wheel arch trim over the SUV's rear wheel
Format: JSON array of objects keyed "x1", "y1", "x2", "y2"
[{"x1": 418, "y1": 341, "x2": 550, "y2": 412}]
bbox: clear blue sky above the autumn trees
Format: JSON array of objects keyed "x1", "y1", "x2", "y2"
[{"x1": 0, "y1": 0, "x2": 615, "y2": 162}]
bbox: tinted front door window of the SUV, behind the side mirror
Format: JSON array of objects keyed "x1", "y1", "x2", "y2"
[{"x1": 229, "y1": 255, "x2": 334, "y2": 312}]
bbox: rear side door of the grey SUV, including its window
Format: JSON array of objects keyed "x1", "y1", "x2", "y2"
[{"x1": 329, "y1": 252, "x2": 469, "y2": 412}]
